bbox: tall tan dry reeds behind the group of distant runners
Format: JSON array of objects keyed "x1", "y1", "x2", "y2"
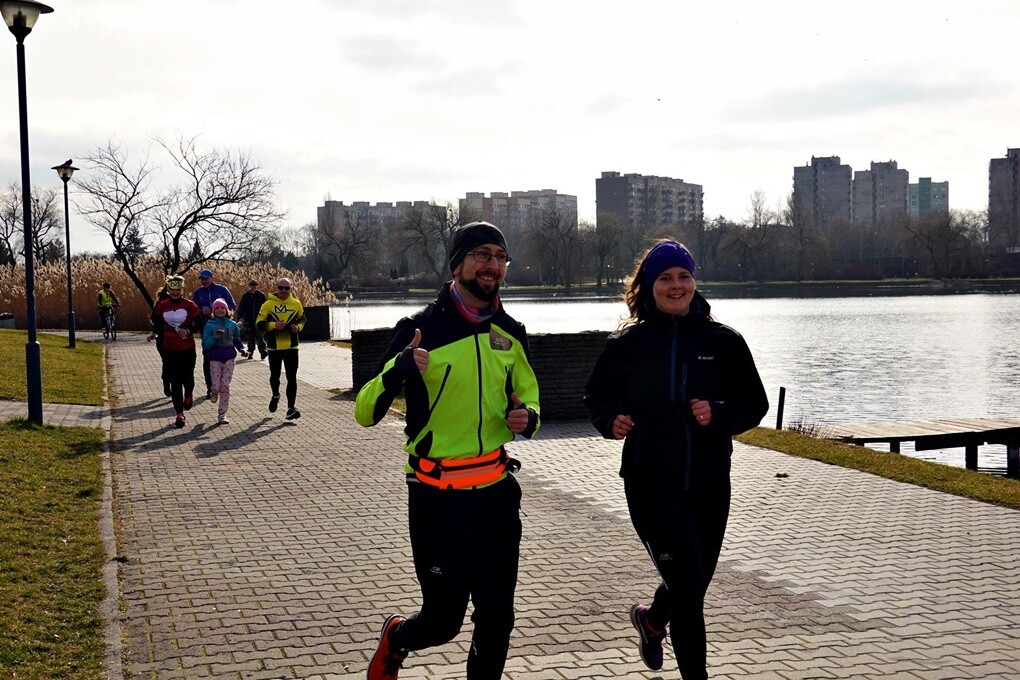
[{"x1": 0, "y1": 258, "x2": 336, "y2": 330}]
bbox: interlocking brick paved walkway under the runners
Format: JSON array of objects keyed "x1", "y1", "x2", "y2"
[{"x1": 21, "y1": 334, "x2": 1020, "y2": 680}]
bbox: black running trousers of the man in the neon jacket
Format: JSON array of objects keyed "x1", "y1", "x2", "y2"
[{"x1": 391, "y1": 475, "x2": 521, "y2": 680}]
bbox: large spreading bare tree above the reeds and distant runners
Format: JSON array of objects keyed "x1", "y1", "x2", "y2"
[{"x1": 75, "y1": 137, "x2": 284, "y2": 305}]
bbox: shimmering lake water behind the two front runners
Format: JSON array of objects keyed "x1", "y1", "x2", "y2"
[{"x1": 332, "y1": 295, "x2": 1020, "y2": 472}]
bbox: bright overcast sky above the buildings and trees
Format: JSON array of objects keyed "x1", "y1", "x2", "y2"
[{"x1": 0, "y1": 0, "x2": 1020, "y2": 252}]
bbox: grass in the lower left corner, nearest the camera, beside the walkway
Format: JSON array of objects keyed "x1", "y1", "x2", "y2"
[{"x1": 0, "y1": 420, "x2": 105, "y2": 679}]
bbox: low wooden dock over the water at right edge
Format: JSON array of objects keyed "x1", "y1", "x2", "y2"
[{"x1": 822, "y1": 418, "x2": 1020, "y2": 477}]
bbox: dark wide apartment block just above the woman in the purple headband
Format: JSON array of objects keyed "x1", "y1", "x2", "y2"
[{"x1": 595, "y1": 171, "x2": 705, "y2": 230}]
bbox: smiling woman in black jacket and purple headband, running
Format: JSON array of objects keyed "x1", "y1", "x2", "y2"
[{"x1": 584, "y1": 241, "x2": 768, "y2": 680}]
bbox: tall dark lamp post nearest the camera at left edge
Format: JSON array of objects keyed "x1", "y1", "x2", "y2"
[{"x1": 0, "y1": 0, "x2": 53, "y2": 425}]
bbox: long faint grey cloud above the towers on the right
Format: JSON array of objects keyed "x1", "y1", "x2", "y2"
[{"x1": 724, "y1": 77, "x2": 1003, "y2": 122}]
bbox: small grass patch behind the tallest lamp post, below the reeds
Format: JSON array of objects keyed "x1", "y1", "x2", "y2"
[{"x1": 0, "y1": 328, "x2": 103, "y2": 406}]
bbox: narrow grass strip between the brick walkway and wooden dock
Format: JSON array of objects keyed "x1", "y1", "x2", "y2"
[{"x1": 736, "y1": 427, "x2": 1020, "y2": 510}]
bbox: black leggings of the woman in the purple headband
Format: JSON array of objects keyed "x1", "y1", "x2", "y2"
[{"x1": 623, "y1": 476, "x2": 729, "y2": 680}]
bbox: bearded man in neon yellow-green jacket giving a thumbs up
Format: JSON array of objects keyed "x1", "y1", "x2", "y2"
[{"x1": 355, "y1": 222, "x2": 540, "y2": 680}]
